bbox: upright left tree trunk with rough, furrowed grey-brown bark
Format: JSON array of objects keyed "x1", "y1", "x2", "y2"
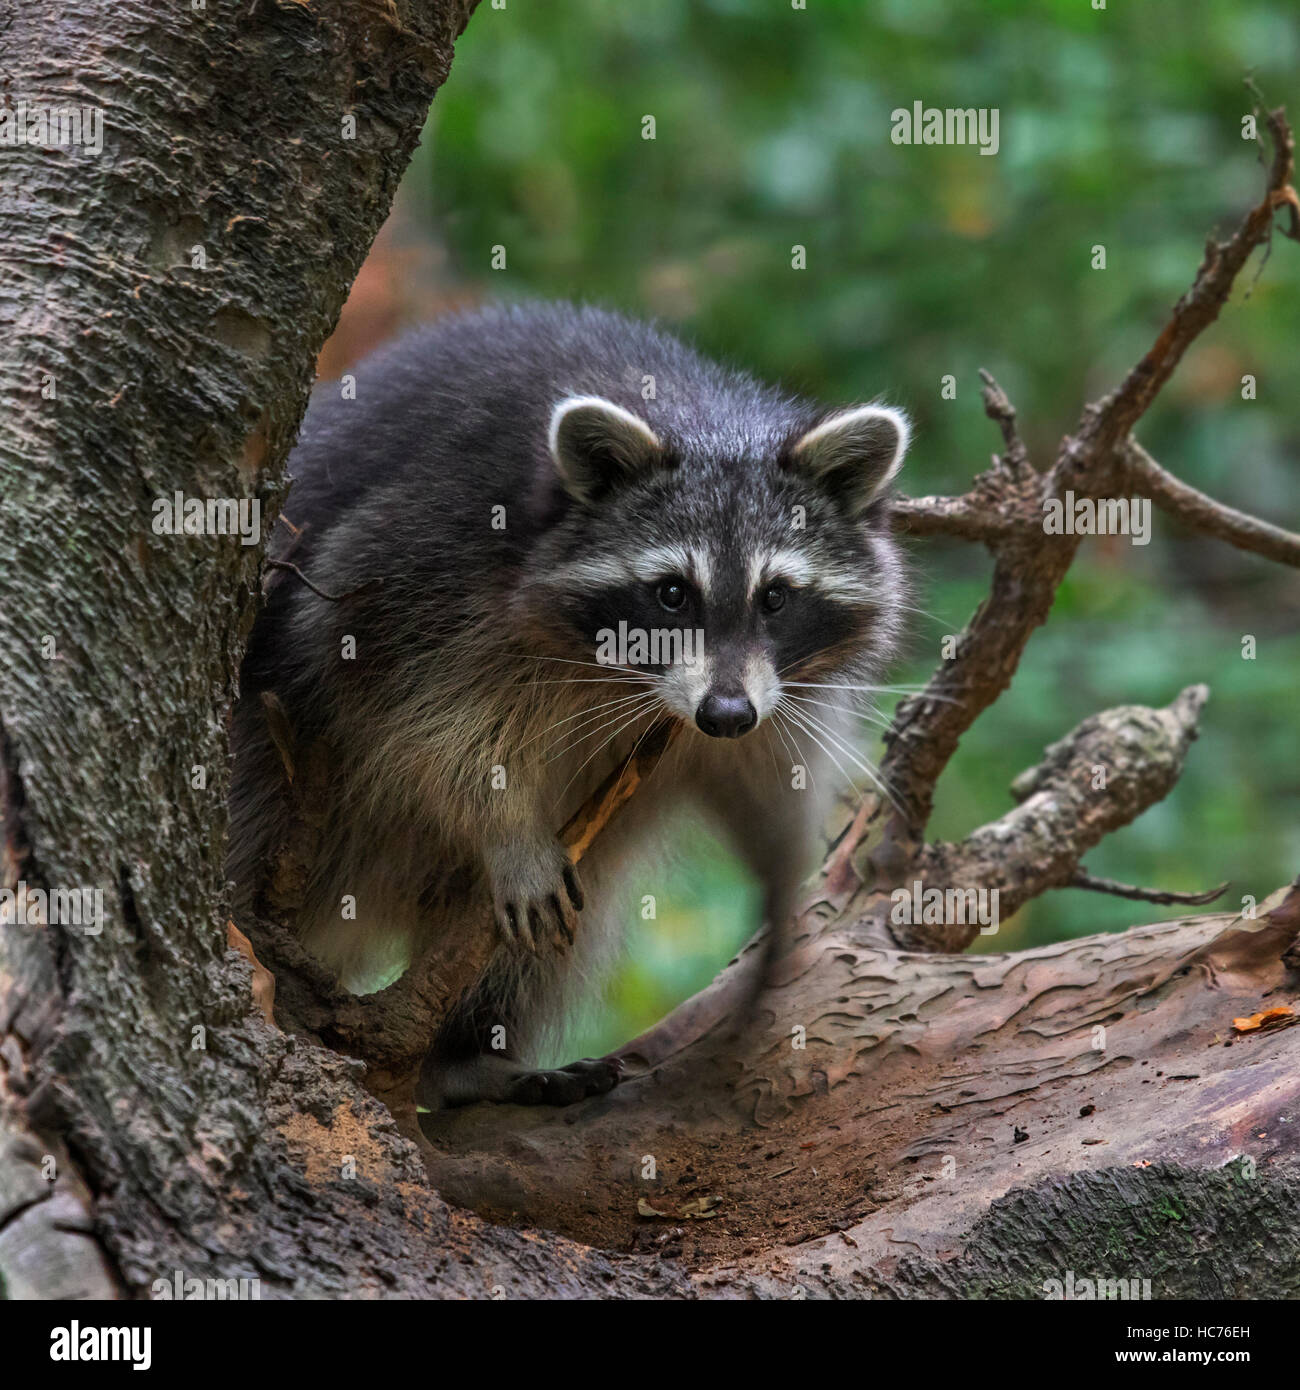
[{"x1": 0, "y1": 0, "x2": 494, "y2": 1291}]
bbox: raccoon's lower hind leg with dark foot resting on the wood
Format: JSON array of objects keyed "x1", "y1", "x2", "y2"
[{"x1": 416, "y1": 962, "x2": 623, "y2": 1111}]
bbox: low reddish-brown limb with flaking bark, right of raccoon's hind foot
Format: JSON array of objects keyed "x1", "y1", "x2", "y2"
[{"x1": 427, "y1": 887, "x2": 1300, "y2": 1298}]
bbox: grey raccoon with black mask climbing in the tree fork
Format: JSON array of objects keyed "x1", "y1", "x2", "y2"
[{"x1": 229, "y1": 304, "x2": 909, "y2": 1108}]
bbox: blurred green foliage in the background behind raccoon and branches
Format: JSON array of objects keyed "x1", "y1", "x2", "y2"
[{"x1": 412, "y1": 0, "x2": 1300, "y2": 1049}]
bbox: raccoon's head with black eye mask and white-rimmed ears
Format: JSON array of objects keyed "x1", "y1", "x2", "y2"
[{"x1": 533, "y1": 396, "x2": 909, "y2": 738}]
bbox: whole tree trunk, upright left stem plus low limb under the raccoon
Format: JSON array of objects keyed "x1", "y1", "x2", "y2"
[{"x1": 0, "y1": 0, "x2": 1300, "y2": 1297}]
